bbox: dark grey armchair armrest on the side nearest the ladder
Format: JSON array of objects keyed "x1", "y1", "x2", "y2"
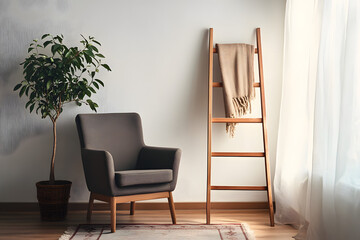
[{"x1": 136, "y1": 146, "x2": 181, "y2": 191}]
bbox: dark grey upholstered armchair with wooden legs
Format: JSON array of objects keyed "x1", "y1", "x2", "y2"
[{"x1": 76, "y1": 113, "x2": 181, "y2": 232}]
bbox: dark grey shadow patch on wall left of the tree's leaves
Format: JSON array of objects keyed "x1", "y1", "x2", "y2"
[{"x1": 0, "y1": 18, "x2": 46, "y2": 155}]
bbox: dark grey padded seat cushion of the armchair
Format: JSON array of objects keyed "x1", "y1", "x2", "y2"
[{"x1": 115, "y1": 169, "x2": 173, "y2": 187}]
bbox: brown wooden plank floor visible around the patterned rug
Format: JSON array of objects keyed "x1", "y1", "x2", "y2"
[{"x1": 0, "y1": 209, "x2": 296, "y2": 240}]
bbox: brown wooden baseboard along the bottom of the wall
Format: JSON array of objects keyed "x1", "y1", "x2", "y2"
[{"x1": 0, "y1": 202, "x2": 268, "y2": 212}]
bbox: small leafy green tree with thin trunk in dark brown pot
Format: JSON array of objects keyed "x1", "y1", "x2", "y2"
[{"x1": 14, "y1": 34, "x2": 111, "y2": 221}]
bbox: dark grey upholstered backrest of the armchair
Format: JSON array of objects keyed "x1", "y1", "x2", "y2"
[{"x1": 76, "y1": 113, "x2": 144, "y2": 171}]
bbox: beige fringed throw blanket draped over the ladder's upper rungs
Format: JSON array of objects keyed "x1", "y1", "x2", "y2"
[{"x1": 217, "y1": 44, "x2": 255, "y2": 137}]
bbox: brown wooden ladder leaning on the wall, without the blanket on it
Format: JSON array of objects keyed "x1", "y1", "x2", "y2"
[{"x1": 206, "y1": 28, "x2": 274, "y2": 226}]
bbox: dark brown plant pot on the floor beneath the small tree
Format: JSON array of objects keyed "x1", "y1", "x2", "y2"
[{"x1": 36, "y1": 180, "x2": 71, "y2": 221}]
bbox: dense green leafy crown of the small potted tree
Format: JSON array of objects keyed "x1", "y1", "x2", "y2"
[{"x1": 14, "y1": 34, "x2": 111, "y2": 122}]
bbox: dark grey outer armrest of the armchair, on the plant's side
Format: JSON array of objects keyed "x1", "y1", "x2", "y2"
[{"x1": 81, "y1": 148, "x2": 115, "y2": 196}]
